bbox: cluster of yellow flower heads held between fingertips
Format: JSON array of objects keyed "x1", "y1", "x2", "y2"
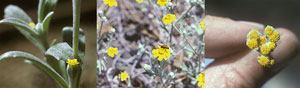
[{"x1": 246, "y1": 25, "x2": 280, "y2": 67}]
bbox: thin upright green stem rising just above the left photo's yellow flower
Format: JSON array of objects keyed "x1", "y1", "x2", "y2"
[{"x1": 73, "y1": 0, "x2": 81, "y2": 59}]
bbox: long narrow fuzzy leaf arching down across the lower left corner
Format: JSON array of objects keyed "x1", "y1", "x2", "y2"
[{"x1": 0, "y1": 51, "x2": 68, "y2": 88}]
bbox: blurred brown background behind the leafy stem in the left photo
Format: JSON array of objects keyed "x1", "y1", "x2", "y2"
[{"x1": 0, "y1": 0, "x2": 97, "y2": 88}]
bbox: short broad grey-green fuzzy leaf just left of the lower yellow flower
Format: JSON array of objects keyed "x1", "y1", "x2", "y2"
[{"x1": 45, "y1": 43, "x2": 73, "y2": 61}]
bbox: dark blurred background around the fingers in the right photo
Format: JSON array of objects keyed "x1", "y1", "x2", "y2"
[{"x1": 206, "y1": 0, "x2": 300, "y2": 88}]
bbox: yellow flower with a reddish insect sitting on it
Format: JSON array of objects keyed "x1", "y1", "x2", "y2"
[{"x1": 152, "y1": 46, "x2": 171, "y2": 61}]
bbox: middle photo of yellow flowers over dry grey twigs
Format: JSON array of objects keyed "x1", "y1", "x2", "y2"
[{"x1": 97, "y1": 0, "x2": 205, "y2": 88}]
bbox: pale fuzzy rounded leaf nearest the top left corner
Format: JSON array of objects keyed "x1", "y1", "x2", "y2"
[{"x1": 4, "y1": 5, "x2": 32, "y2": 24}]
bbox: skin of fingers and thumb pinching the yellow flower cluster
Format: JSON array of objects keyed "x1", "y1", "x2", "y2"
[{"x1": 205, "y1": 16, "x2": 300, "y2": 88}]
